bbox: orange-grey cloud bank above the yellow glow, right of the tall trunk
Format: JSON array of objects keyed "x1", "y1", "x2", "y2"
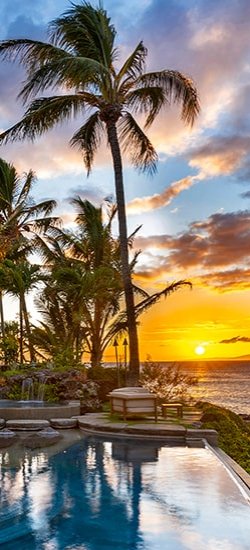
[{"x1": 135, "y1": 210, "x2": 250, "y2": 292}]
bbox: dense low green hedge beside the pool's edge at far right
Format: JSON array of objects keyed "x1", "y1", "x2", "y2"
[{"x1": 201, "y1": 403, "x2": 250, "y2": 474}]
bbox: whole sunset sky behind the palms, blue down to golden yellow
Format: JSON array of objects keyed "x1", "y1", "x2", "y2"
[{"x1": 0, "y1": 0, "x2": 250, "y2": 360}]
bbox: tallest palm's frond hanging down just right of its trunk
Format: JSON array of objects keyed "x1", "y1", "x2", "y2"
[{"x1": 119, "y1": 112, "x2": 158, "y2": 173}]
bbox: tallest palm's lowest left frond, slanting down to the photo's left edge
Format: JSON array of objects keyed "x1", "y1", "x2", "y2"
[{"x1": 0, "y1": 94, "x2": 84, "y2": 143}]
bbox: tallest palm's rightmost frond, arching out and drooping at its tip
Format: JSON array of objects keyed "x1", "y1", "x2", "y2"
[{"x1": 136, "y1": 70, "x2": 200, "y2": 126}]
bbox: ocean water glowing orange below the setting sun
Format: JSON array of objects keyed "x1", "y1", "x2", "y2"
[{"x1": 158, "y1": 361, "x2": 250, "y2": 415}]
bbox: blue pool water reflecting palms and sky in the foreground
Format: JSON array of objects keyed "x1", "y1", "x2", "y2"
[{"x1": 0, "y1": 437, "x2": 250, "y2": 550}]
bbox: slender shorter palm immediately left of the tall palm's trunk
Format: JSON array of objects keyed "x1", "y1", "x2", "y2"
[{"x1": 64, "y1": 197, "x2": 123, "y2": 367}]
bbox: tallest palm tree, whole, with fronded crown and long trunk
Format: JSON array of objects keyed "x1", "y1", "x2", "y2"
[{"x1": 0, "y1": 2, "x2": 199, "y2": 384}]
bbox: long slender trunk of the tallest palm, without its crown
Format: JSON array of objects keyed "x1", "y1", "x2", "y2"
[{"x1": 106, "y1": 120, "x2": 140, "y2": 386}]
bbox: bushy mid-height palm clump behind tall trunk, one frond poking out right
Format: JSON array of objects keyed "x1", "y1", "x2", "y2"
[{"x1": 32, "y1": 197, "x2": 190, "y2": 368}]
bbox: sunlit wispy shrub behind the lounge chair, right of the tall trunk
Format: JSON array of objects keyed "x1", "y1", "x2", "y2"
[{"x1": 140, "y1": 356, "x2": 197, "y2": 403}]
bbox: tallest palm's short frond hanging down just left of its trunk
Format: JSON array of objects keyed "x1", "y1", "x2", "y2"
[{"x1": 70, "y1": 111, "x2": 104, "y2": 174}]
